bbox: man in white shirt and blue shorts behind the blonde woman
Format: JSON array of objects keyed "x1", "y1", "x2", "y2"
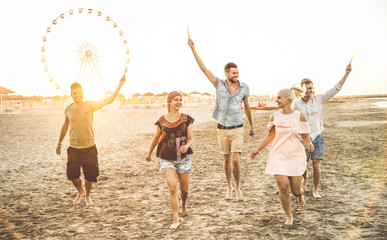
[{"x1": 294, "y1": 63, "x2": 352, "y2": 198}]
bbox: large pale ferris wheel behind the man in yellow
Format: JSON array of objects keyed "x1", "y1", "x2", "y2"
[{"x1": 41, "y1": 8, "x2": 129, "y2": 99}]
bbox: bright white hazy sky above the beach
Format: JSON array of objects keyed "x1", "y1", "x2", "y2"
[{"x1": 0, "y1": 0, "x2": 387, "y2": 96}]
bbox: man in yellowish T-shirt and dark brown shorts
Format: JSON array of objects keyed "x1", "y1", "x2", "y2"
[{"x1": 56, "y1": 74, "x2": 126, "y2": 206}]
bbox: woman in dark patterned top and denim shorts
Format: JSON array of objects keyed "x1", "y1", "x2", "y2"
[{"x1": 146, "y1": 91, "x2": 194, "y2": 229}]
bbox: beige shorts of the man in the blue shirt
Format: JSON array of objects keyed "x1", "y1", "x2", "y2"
[{"x1": 216, "y1": 127, "x2": 243, "y2": 154}]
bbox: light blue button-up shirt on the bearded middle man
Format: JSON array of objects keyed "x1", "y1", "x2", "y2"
[{"x1": 212, "y1": 78, "x2": 250, "y2": 127}]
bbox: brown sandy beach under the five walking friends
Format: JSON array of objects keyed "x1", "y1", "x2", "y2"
[{"x1": 0, "y1": 99, "x2": 387, "y2": 240}]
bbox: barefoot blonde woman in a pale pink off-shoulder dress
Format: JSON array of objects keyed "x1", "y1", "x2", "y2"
[{"x1": 250, "y1": 87, "x2": 314, "y2": 225}]
